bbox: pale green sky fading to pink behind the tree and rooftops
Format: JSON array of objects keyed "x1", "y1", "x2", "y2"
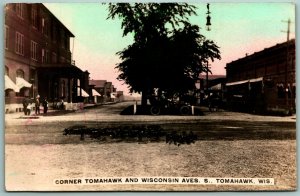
[{"x1": 44, "y1": 3, "x2": 295, "y2": 94}]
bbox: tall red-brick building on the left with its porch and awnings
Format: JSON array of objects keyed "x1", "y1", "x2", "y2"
[{"x1": 4, "y1": 3, "x2": 89, "y2": 111}]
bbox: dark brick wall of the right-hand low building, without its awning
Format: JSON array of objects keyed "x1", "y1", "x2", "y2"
[{"x1": 226, "y1": 40, "x2": 296, "y2": 111}]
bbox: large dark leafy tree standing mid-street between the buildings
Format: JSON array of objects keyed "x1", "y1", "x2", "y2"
[{"x1": 108, "y1": 3, "x2": 221, "y2": 104}]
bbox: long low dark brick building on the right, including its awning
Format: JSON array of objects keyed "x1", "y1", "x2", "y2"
[{"x1": 226, "y1": 39, "x2": 296, "y2": 114}]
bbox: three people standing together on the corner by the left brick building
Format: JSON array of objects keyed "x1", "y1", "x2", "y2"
[{"x1": 23, "y1": 95, "x2": 48, "y2": 115}]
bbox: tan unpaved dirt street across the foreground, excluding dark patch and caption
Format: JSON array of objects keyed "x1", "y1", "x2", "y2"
[{"x1": 5, "y1": 103, "x2": 296, "y2": 191}]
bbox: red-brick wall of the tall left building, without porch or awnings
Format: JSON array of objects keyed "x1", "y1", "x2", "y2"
[{"x1": 4, "y1": 3, "x2": 74, "y2": 111}]
